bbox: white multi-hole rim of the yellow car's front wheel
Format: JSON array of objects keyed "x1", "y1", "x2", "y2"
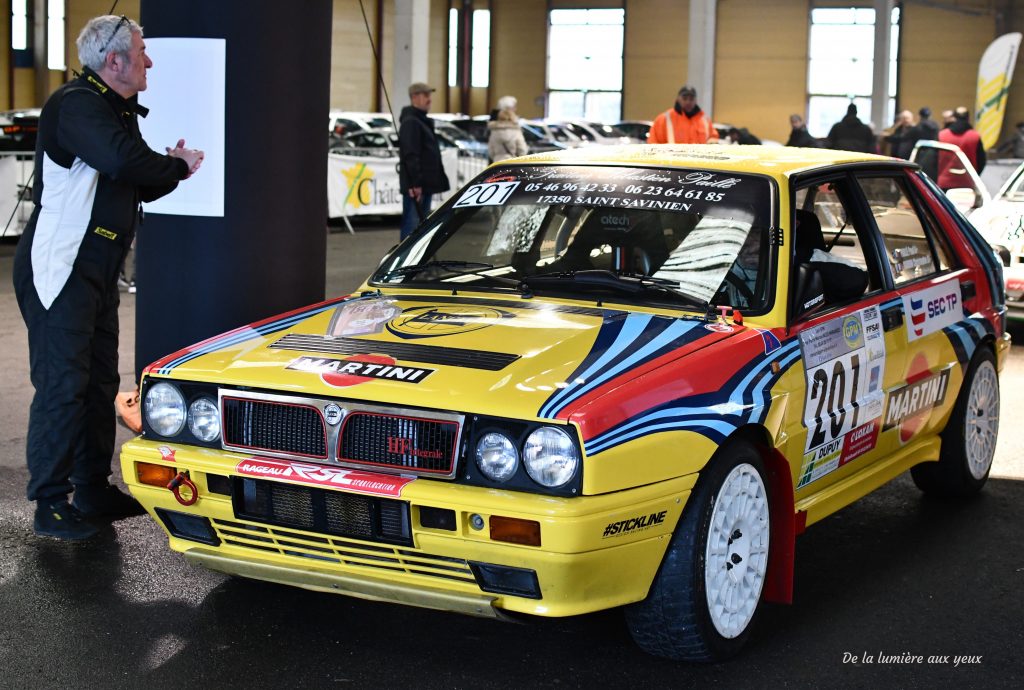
[{"x1": 705, "y1": 463, "x2": 769, "y2": 639}]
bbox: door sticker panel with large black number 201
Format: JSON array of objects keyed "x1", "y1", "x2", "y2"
[{"x1": 798, "y1": 305, "x2": 886, "y2": 488}]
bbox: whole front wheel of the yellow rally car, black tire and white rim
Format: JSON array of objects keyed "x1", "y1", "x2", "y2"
[{"x1": 626, "y1": 441, "x2": 770, "y2": 661}]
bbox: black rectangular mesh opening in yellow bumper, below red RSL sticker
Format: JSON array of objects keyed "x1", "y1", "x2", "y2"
[{"x1": 232, "y1": 477, "x2": 413, "y2": 545}]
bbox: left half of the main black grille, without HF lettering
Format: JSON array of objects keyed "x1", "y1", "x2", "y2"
[{"x1": 222, "y1": 396, "x2": 327, "y2": 460}]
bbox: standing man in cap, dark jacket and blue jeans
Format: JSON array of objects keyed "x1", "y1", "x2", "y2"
[{"x1": 398, "y1": 82, "x2": 451, "y2": 240}]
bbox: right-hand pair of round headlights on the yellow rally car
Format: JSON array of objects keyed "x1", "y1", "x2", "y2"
[{"x1": 475, "y1": 427, "x2": 580, "y2": 488}]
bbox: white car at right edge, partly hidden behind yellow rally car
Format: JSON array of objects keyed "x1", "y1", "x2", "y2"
[{"x1": 910, "y1": 140, "x2": 1024, "y2": 320}]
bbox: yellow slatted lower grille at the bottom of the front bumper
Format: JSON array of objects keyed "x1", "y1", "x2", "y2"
[{"x1": 211, "y1": 520, "x2": 477, "y2": 589}]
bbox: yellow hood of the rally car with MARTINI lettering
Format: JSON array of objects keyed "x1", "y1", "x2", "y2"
[{"x1": 146, "y1": 295, "x2": 745, "y2": 419}]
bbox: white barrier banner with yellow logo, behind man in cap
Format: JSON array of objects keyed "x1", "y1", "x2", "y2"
[{"x1": 327, "y1": 148, "x2": 459, "y2": 218}]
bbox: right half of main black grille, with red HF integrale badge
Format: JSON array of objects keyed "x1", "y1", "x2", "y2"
[{"x1": 338, "y1": 412, "x2": 459, "y2": 475}]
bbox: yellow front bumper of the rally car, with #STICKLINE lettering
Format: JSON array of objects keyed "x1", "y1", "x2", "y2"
[{"x1": 121, "y1": 438, "x2": 696, "y2": 617}]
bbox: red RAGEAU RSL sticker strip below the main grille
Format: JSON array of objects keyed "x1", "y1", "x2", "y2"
[{"x1": 234, "y1": 458, "x2": 416, "y2": 499}]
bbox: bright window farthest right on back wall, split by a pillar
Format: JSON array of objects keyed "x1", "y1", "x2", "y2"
[{"x1": 807, "y1": 7, "x2": 900, "y2": 137}]
